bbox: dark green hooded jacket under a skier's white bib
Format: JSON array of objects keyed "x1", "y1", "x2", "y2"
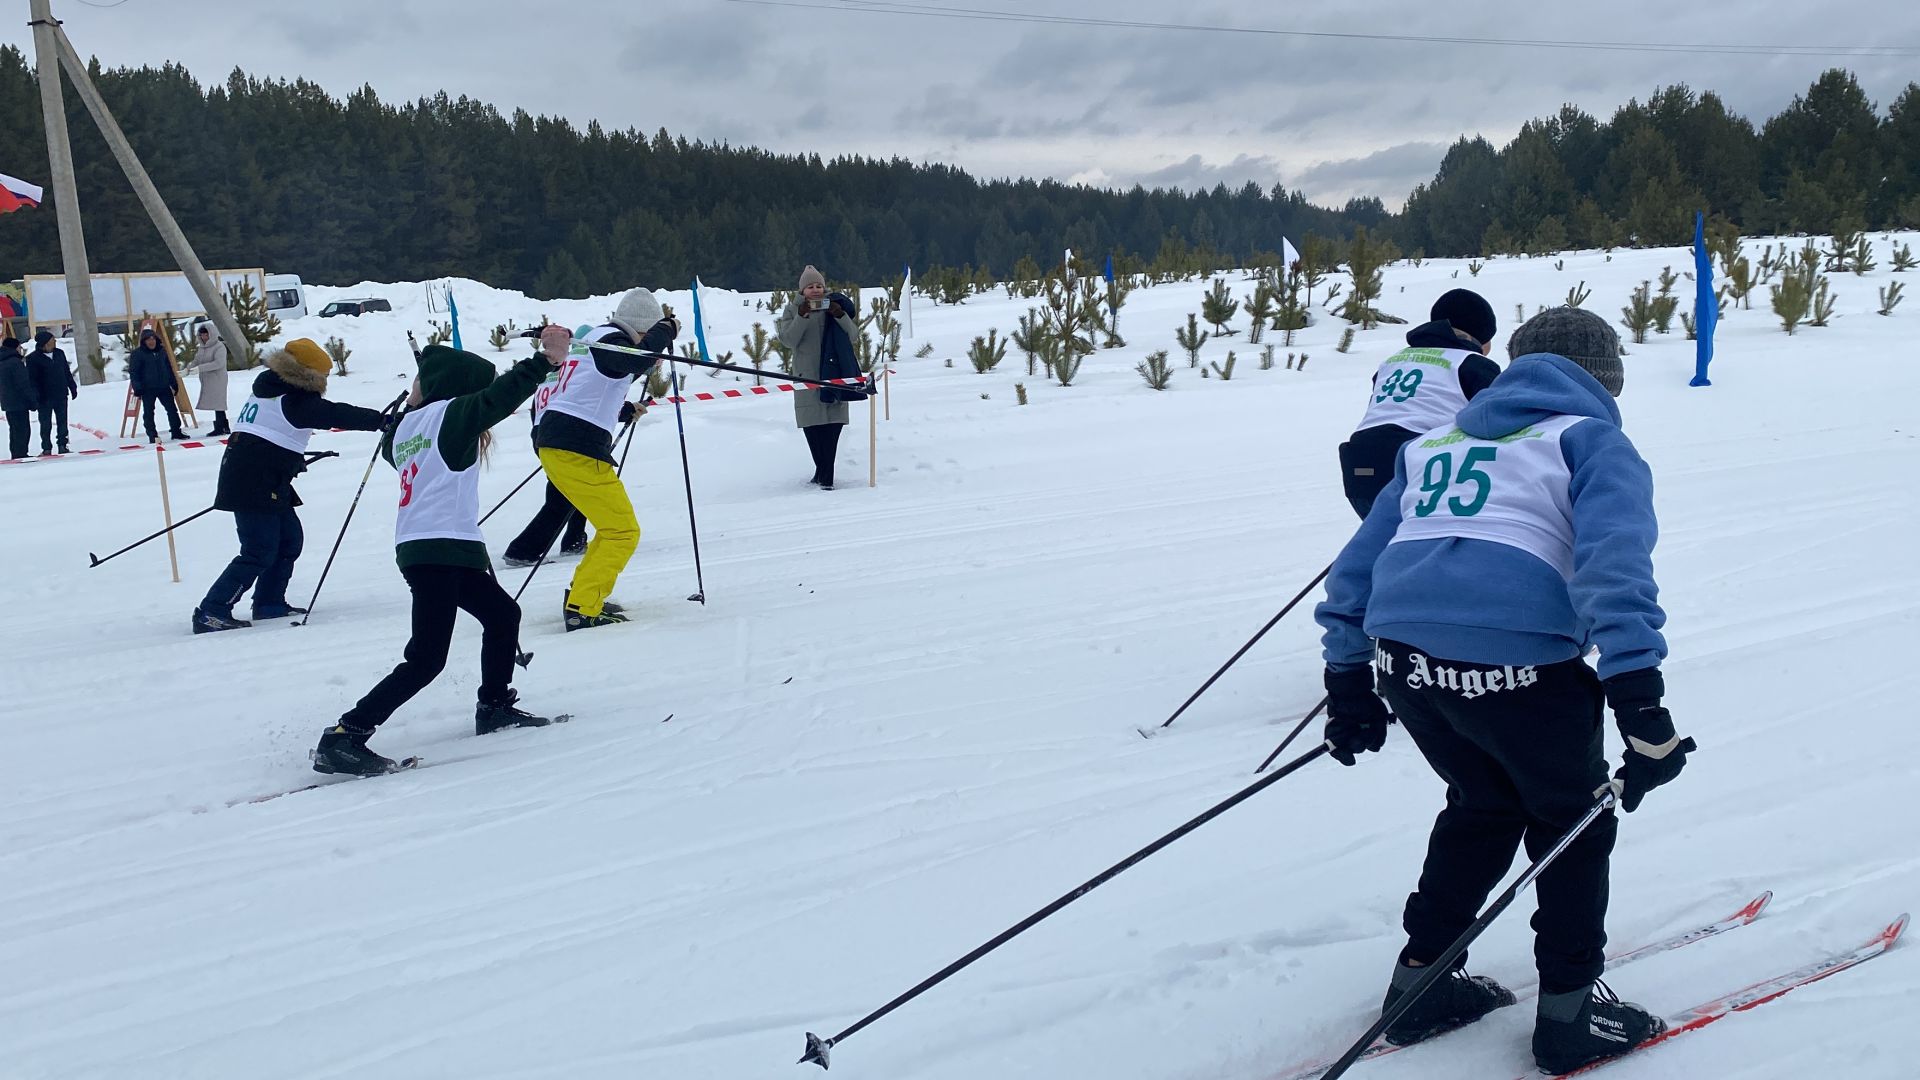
[{"x1": 380, "y1": 346, "x2": 553, "y2": 571}]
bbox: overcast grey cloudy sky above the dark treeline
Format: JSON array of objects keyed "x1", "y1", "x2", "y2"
[{"x1": 4, "y1": 0, "x2": 1920, "y2": 208}]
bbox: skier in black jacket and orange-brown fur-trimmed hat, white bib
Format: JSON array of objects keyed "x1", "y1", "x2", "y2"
[{"x1": 194, "y1": 338, "x2": 384, "y2": 634}]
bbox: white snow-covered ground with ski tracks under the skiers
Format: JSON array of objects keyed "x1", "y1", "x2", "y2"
[{"x1": 0, "y1": 236, "x2": 1920, "y2": 1080}]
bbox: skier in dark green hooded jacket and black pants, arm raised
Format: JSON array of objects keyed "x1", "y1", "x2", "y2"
[{"x1": 313, "y1": 336, "x2": 566, "y2": 776}]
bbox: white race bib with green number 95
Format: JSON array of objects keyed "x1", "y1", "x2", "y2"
[{"x1": 1392, "y1": 415, "x2": 1588, "y2": 588}]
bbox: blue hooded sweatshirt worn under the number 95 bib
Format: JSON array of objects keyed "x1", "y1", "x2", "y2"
[{"x1": 1313, "y1": 354, "x2": 1667, "y2": 678}]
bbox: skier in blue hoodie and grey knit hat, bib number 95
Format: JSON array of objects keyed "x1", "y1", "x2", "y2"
[{"x1": 1315, "y1": 307, "x2": 1693, "y2": 1072}]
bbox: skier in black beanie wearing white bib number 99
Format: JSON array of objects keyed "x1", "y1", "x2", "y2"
[{"x1": 1340, "y1": 288, "x2": 1500, "y2": 517}]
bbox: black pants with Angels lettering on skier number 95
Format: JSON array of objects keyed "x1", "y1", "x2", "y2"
[{"x1": 1375, "y1": 640, "x2": 1619, "y2": 994}]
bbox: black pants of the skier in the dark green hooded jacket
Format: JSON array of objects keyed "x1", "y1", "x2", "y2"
[{"x1": 340, "y1": 567, "x2": 520, "y2": 730}]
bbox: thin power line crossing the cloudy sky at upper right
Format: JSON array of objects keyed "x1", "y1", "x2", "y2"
[{"x1": 726, "y1": 0, "x2": 1920, "y2": 56}]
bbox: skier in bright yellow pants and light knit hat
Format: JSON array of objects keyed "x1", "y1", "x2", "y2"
[{"x1": 534, "y1": 288, "x2": 680, "y2": 632}]
